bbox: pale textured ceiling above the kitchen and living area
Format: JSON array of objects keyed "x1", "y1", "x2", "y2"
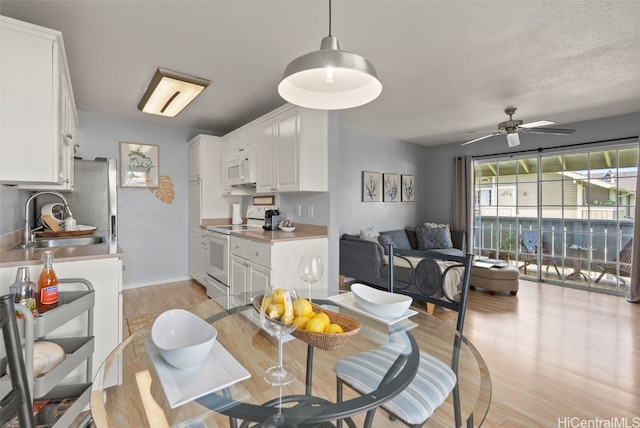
[{"x1": 0, "y1": 0, "x2": 640, "y2": 146}]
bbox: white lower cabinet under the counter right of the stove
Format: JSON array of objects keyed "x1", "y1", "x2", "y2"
[{"x1": 229, "y1": 235, "x2": 328, "y2": 294}]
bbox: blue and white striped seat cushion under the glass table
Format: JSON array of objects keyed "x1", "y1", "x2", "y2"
[{"x1": 334, "y1": 343, "x2": 456, "y2": 424}]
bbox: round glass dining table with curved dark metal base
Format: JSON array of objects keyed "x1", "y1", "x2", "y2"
[{"x1": 91, "y1": 290, "x2": 491, "y2": 428}]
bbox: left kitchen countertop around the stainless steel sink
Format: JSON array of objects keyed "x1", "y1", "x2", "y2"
[{"x1": 0, "y1": 231, "x2": 124, "y2": 268}]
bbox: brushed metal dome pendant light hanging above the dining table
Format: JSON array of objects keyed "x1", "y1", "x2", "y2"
[{"x1": 278, "y1": 0, "x2": 382, "y2": 110}]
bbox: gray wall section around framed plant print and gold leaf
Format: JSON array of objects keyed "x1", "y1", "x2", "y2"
[{"x1": 78, "y1": 112, "x2": 210, "y2": 286}]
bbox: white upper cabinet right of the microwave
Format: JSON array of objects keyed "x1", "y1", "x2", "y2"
[{"x1": 256, "y1": 105, "x2": 328, "y2": 193}]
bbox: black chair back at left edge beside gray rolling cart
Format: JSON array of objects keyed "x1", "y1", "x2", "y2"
[{"x1": 0, "y1": 294, "x2": 35, "y2": 428}]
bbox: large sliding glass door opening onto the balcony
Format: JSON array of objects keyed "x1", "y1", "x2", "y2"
[{"x1": 474, "y1": 142, "x2": 638, "y2": 294}]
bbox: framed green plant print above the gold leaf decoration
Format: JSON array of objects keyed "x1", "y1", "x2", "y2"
[{"x1": 120, "y1": 141, "x2": 160, "y2": 187}]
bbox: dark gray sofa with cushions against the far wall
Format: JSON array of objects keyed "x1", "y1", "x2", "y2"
[{"x1": 340, "y1": 223, "x2": 466, "y2": 302}]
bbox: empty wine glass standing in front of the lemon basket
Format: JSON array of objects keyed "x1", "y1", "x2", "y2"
[{"x1": 260, "y1": 286, "x2": 297, "y2": 385}]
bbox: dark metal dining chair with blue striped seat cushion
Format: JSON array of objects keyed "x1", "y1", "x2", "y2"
[{"x1": 334, "y1": 246, "x2": 473, "y2": 427}]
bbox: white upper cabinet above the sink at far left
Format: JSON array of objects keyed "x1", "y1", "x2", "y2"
[{"x1": 0, "y1": 16, "x2": 77, "y2": 190}]
